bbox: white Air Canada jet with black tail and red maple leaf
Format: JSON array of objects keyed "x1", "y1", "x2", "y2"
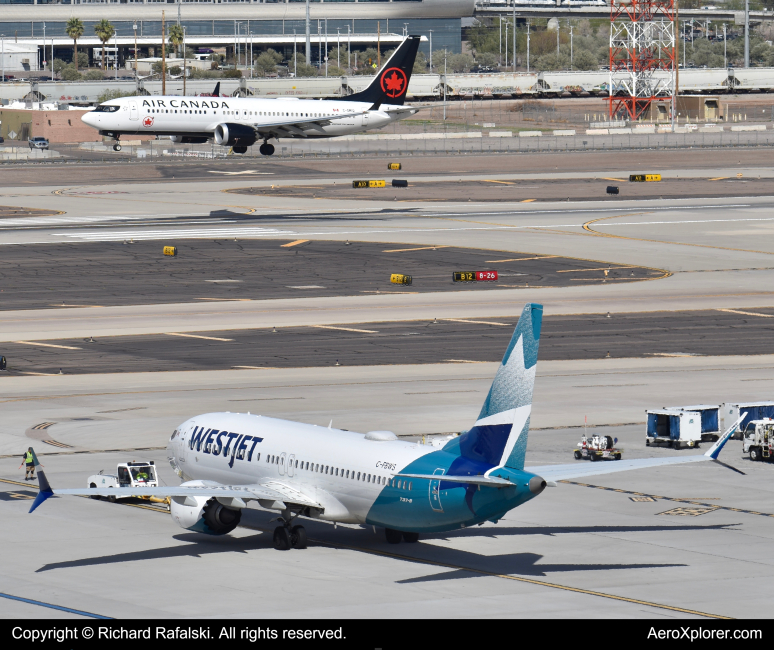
[{"x1": 81, "y1": 36, "x2": 422, "y2": 156}]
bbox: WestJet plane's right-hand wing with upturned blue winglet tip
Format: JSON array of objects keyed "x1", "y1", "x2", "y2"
[{"x1": 524, "y1": 413, "x2": 747, "y2": 485}]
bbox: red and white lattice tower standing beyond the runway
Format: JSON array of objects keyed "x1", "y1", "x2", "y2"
[{"x1": 608, "y1": 0, "x2": 677, "y2": 120}]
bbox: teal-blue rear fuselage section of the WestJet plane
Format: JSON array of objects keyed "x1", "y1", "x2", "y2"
[{"x1": 366, "y1": 451, "x2": 535, "y2": 532}]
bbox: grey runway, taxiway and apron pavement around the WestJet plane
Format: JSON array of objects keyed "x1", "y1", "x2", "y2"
[{"x1": 0, "y1": 149, "x2": 774, "y2": 619}]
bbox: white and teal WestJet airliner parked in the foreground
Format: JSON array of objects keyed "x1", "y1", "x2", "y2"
[{"x1": 30, "y1": 304, "x2": 746, "y2": 550}]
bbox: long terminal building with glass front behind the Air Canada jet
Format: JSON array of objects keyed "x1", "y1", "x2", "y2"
[{"x1": 0, "y1": 0, "x2": 475, "y2": 70}]
